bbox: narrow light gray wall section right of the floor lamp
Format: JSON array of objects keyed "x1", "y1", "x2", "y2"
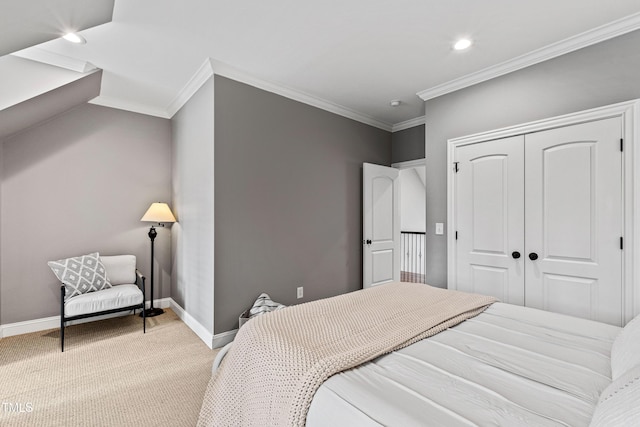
[{"x1": 171, "y1": 78, "x2": 217, "y2": 334}]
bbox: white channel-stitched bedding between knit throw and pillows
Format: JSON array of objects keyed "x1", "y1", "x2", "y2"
[{"x1": 307, "y1": 303, "x2": 621, "y2": 427}]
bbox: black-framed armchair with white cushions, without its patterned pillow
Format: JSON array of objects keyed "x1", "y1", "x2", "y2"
[{"x1": 60, "y1": 255, "x2": 147, "y2": 352}]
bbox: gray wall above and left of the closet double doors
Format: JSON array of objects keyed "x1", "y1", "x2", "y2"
[{"x1": 425, "y1": 31, "x2": 640, "y2": 287}]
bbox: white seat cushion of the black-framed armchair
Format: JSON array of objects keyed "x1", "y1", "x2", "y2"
[{"x1": 64, "y1": 285, "x2": 143, "y2": 317}]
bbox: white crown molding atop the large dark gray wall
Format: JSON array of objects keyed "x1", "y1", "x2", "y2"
[{"x1": 211, "y1": 59, "x2": 392, "y2": 132}]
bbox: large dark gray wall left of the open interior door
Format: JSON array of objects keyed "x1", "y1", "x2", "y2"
[{"x1": 214, "y1": 76, "x2": 391, "y2": 333}]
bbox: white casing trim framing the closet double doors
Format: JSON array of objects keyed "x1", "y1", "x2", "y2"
[{"x1": 447, "y1": 100, "x2": 640, "y2": 323}]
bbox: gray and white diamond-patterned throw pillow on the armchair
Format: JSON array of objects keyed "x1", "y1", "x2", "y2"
[{"x1": 47, "y1": 252, "x2": 111, "y2": 301}]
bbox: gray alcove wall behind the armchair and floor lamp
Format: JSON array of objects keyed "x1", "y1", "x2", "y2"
[{"x1": 0, "y1": 104, "x2": 171, "y2": 324}]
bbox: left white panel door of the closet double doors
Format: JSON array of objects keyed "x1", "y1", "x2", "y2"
[{"x1": 455, "y1": 136, "x2": 524, "y2": 305}]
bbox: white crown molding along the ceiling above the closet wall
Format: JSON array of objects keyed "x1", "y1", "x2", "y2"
[{"x1": 417, "y1": 13, "x2": 640, "y2": 101}]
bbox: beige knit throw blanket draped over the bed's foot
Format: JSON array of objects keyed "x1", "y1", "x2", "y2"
[{"x1": 198, "y1": 282, "x2": 495, "y2": 427}]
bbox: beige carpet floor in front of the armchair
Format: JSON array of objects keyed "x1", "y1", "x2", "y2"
[{"x1": 0, "y1": 310, "x2": 217, "y2": 427}]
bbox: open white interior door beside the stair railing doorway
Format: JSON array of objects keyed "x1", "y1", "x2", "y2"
[{"x1": 362, "y1": 163, "x2": 400, "y2": 288}]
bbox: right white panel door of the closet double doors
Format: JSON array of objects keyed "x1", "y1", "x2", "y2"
[{"x1": 525, "y1": 118, "x2": 624, "y2": 325}]
